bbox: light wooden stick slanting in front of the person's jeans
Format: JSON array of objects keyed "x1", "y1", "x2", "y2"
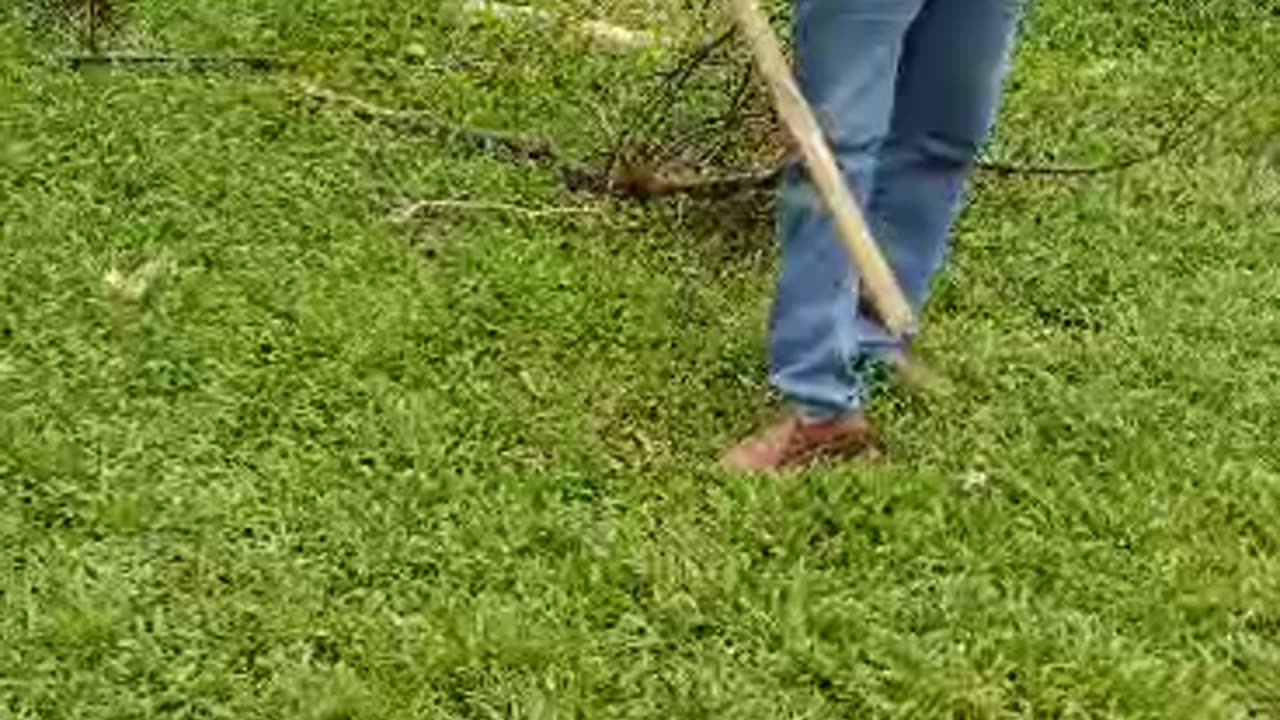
[{"x1": 730, "y1": 0, "x2": 913, "y2": 337}]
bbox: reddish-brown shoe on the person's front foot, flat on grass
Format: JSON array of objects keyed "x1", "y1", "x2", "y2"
[{"x1": 721, "y1": 414, "x2": 883, "y2": 474}]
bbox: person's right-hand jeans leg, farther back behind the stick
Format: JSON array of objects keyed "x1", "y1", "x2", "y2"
[{"x1": 856, "y1": 0, "x2": 1024, "y2": 356}]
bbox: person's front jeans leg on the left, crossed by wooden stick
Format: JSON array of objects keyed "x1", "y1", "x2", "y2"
[{"x1": 769, "y1": 0, "x2": 924, "y2": 419}]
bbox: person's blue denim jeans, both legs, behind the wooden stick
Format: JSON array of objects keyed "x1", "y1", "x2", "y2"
[{"x1": 769, "y1": 0, "x2": 1023, "y2": 418}]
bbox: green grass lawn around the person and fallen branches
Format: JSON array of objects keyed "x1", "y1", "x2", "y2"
[{"x1": 0, "y1": 0, "x2": 1280, "y2": 720}]
